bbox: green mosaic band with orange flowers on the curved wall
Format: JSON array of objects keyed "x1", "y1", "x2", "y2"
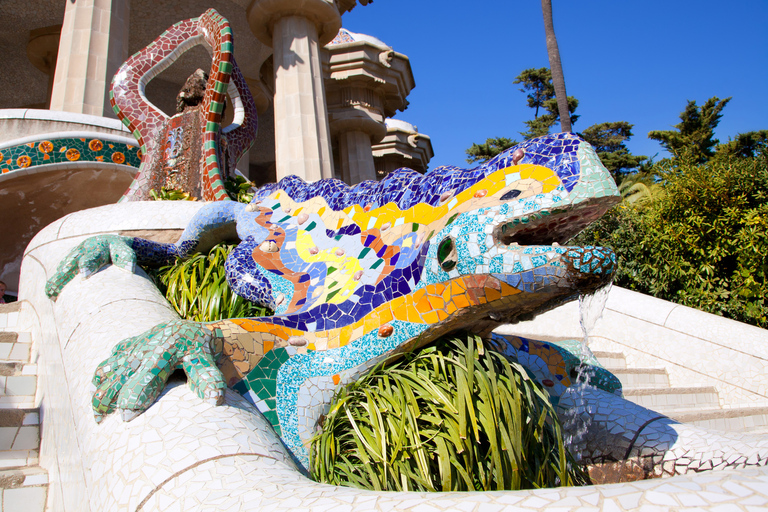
[{"x1": 0, "y1": 137, "x2": 141, "y2": 174}]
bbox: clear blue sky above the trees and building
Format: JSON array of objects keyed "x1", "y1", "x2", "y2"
[{"x1": 343, "y1": 0, "x2": 768, "y2": 168}]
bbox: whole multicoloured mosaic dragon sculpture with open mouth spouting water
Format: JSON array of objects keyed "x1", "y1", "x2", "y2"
[{"x1": 46, "y1": 134, "x2": 619, "y2": 462}]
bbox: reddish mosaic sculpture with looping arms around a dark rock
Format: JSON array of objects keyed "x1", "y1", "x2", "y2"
[{"x1": 109, "y1": 9, "x2": 257, "y2": 201}]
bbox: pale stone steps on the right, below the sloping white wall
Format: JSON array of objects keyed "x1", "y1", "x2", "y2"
[{"x1": 594, "y1": 351, "x2": 768, "y2": 433}]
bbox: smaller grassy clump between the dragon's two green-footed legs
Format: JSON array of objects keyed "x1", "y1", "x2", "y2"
[{"x1": 149, "y1": 243, "x2": 272, "y2": 322}]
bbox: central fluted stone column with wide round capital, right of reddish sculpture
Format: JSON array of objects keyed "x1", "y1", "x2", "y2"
[{"x1": 248, "y1": 0, "x2": 341, "y2": 181}]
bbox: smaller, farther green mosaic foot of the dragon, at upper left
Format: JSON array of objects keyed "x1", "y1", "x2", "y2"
[{"x1": 45, "y1": 235, "x2": 136, "y2": 300}]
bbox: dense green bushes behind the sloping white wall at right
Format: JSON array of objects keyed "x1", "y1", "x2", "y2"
[{"x1": 576, "y1": 151, "x2": 768, "y2": 327}]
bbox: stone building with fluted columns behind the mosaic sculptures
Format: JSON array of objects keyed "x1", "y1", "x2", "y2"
[{"x1": 0, "y1": 0, "x2": 432, "y2": 291}]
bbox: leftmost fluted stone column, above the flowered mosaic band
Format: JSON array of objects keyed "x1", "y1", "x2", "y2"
[{"x1": 51, "y1": 0, "x2": 130, "y2": 117}]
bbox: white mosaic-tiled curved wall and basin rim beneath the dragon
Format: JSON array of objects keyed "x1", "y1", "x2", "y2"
[{"x1": 15, "y1": 202, "x2": 768, "y2": 512}]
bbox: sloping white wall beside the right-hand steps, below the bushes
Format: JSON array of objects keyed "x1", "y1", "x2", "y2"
[{"x1": 500, "y1": 286, "x2": 768, "y2": 408}]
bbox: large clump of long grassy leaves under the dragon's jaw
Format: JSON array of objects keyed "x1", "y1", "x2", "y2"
[{"x1": 310, "y1": 335, "x2": 587, "y2": 491}]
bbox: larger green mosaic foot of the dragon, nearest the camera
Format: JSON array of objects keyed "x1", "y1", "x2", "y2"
[{"x1": 92, "y1": 320, "x2": 226, "y2": 422}]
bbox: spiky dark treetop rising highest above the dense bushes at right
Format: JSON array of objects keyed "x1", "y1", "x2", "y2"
[{"x1": 648, "y1": 96, "x2": 731, "y2": 163}]
